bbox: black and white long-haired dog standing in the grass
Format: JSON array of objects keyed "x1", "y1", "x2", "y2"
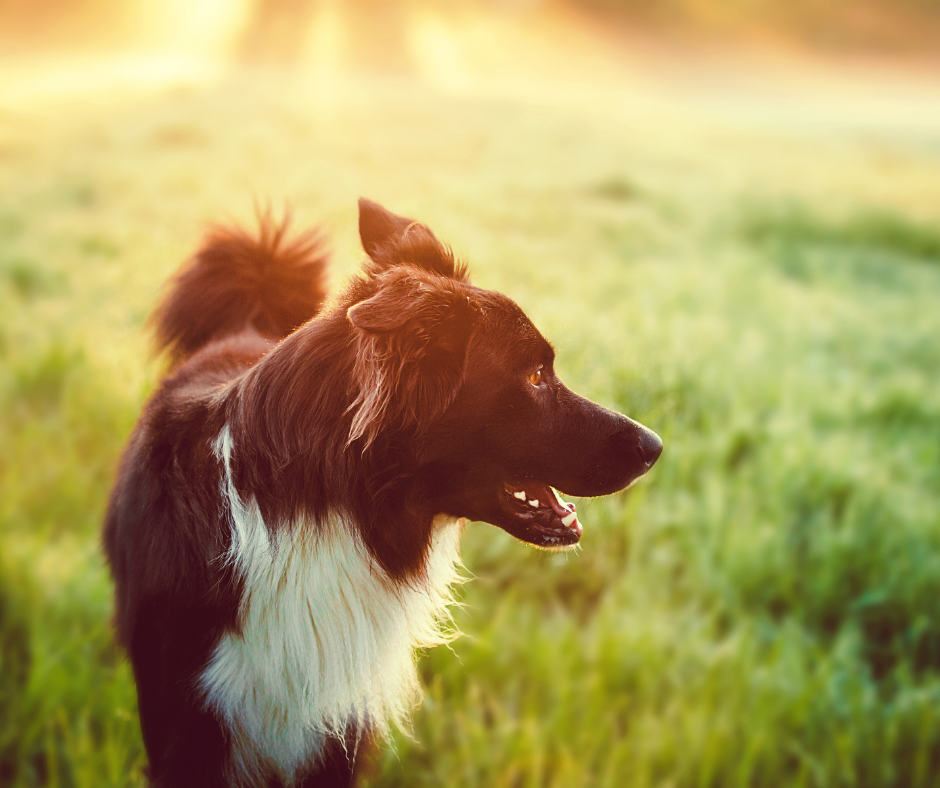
[{"x1": 104, "y1": 199, "x2": 662, "y2": 788}]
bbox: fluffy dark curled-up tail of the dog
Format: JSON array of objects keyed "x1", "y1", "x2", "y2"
[{"x1": 150, "y1": 212, "x2": 327, "y2": 362}]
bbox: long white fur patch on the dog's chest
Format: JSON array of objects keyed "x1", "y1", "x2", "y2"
[{"x1": 202, "y1": 426, "x2": 461, "y2": 784}]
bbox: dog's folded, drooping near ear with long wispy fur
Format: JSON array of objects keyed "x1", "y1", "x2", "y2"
[{"x1": 346, "y1": 266, "x2": 479, "y2": 445}]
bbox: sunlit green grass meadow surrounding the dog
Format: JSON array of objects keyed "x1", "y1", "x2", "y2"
[{"x1": 0, "y1": 69, "x2": 940, "y2": 788}]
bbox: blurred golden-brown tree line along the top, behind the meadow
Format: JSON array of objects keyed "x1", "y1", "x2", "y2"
[{"x1": 0, "y1": 0, "x2": 940, "y2": 57}]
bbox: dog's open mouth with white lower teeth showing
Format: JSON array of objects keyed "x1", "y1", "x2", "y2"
[{"x1": 501, "y1": 479, "x2": 583, "y2": 550}]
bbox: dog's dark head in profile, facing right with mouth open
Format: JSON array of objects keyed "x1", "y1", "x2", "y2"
[{"x1": 346, "y1": 200, "x2": 662, "y2": 549}]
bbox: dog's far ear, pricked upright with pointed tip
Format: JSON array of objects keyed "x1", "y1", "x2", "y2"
[{"x1": 359, "y1": 197, "x2": 467, "y2": 282}]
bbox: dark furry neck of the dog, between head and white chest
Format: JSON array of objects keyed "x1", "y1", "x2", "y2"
[{"x1": 224, "y1": 322, "x2": 452, "y2": 580}]
